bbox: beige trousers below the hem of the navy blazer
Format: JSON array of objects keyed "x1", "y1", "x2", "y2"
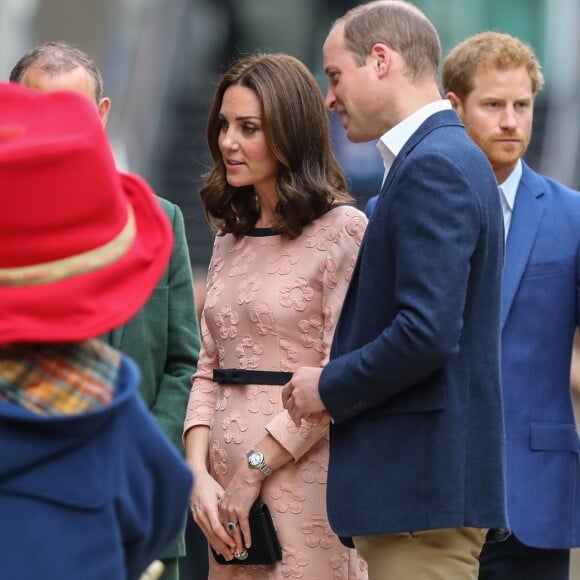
[{"x1": 353, "y1": 528, "x2": 487, "y2": 580}]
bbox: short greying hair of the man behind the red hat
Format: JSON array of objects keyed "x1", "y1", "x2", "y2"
[{"x1": 10, "y1": 42, "x2": 103, "y2": 103}]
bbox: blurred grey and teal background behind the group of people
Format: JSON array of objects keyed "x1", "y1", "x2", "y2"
[{"x1": 0, "y1": 0, "x2": 580, "y2": 578}]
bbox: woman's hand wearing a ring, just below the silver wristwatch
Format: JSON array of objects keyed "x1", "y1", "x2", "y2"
[{"x1": 219, "y1": 464, "x2": 265, "y2": 554}]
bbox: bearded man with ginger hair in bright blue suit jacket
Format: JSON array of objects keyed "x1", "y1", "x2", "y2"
[{"x1": 443, "y1": 32, "x2": 580, "y2": 580}]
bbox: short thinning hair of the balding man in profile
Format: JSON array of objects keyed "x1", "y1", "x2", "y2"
[{"x1": 333, "y1": 0, "x2": 441, "y2": 81}]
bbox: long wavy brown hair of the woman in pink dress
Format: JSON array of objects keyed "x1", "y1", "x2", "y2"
[{"x1": 200, "y1": 54, "x2": 352, "y2": 238}]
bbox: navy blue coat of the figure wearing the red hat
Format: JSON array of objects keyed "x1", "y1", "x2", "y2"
[{"x1": 0, "y1": 357, "x2": 192, "y2": 580}]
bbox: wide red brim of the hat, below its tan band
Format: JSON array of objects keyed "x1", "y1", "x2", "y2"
[{"x1": 0, "y1": 173, "x2": 173, "y2": 344}]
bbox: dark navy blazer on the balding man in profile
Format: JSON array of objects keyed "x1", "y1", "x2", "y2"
[{"x1": 319, "y1": 111, "x2": 507, "y2": 543}]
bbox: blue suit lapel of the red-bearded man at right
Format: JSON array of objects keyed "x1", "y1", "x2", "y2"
[{"x1": 501, "y1": 164, "x2": 544, "y2": 329}]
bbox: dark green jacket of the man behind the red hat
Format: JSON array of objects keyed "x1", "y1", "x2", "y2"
[{"x1": 102, "y1": 198, "x2": 200, "y2": 558}]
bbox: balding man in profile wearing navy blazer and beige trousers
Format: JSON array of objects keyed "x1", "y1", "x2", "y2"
[{"x1": 283, "y1": 0, "x2": 507, "y2": 580}]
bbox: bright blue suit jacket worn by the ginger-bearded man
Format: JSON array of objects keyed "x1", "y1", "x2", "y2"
[{"x1": 502, "y1": 164, "x2": 580, "y2": 548}]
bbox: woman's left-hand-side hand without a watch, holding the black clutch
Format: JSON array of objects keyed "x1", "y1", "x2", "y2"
[{"x1": 190, "y1": 472, "x2": 237, "y2": 560}]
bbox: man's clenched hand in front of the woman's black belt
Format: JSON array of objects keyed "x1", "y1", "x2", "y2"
[{"x1": 282, "y1": 367, "x2": 326, "y2": 427}]
